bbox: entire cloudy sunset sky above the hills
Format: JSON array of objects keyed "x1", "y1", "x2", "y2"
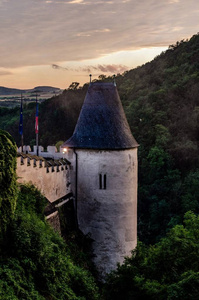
[{"x1": 0, "y1": 0, "x2": 199, "y2": 89}]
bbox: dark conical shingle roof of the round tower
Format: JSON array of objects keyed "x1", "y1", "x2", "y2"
[{"x1": 62, "y1": 83, "x2": 138, "y2": 150}]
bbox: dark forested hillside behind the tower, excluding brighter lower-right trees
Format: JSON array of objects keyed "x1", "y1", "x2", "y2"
[{"x1": 0, "y1": 34, "x2": 199, "y2": 243}]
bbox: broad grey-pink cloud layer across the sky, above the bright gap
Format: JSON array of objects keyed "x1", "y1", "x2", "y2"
[{"x1": 0, "y1": 0, "x2": 199, "y2": 68}]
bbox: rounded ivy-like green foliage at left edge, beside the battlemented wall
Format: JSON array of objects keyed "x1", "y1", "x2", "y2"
[{"x1": 0, "y1": 130, "x2": 17, "y2": 235}]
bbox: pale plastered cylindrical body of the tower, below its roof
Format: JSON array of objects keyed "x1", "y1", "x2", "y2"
[{"x1": 76, "y1": 148, "x2": 137, "y2": 277}]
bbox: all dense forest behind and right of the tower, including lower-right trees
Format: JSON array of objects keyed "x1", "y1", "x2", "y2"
[{"x1": 0, "y1": 34, "x2": 199, "y2": 300}]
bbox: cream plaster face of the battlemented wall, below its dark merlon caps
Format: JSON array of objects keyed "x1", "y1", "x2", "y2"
[{"x1": 17, "y1": 157, "x2": 71, "y2": 202}]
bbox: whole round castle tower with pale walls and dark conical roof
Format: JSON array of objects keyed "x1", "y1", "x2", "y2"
[{"x1": 62, "y1": 83, "x2": 138, "y2": 277}]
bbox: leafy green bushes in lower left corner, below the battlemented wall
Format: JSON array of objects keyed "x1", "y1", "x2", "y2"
[{"x1": 0, "y1": 185, "x2": 98, "y2": 300}]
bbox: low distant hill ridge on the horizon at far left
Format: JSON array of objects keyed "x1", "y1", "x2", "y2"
[{"x1": 0, "y1": 86, "x2": 61, "y2": 95}]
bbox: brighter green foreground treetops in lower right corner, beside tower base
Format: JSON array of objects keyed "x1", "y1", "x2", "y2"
[{"x1": 105, "y1": 212, "x2": 199, "y2": 300}]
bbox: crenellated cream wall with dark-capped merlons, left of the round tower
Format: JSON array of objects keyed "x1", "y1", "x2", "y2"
[{"x1": 17, "y1": 152, "x2": 71, "y2": 202}]
